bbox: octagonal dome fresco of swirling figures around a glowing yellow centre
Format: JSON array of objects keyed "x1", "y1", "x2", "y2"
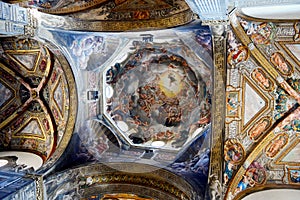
[{"x1": 104, "y1": 43, "x2": 210, "y2": 150}]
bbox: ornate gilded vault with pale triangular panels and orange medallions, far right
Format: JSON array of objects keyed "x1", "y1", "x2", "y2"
[{"x1": 224, "y1": 10, "x2": 300, "y2": 199}]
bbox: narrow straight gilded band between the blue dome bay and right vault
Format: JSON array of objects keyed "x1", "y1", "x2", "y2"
[{"x1": 209, "y1": 26, "x2": 226, "y2": 199}]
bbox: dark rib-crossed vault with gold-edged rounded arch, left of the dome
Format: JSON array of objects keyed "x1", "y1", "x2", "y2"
[{"x1": 0, "y1": 38, "x2": 76, "y2": 168}]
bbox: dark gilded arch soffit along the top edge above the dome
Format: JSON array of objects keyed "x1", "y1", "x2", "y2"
[{"x1": 21, "y1": 0, "x2": 194, "y2": 31}]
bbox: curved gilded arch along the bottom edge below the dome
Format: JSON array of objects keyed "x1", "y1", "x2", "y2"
[{"x1": 45, "y1": 163, "x2": 197, "y2": 200}]
